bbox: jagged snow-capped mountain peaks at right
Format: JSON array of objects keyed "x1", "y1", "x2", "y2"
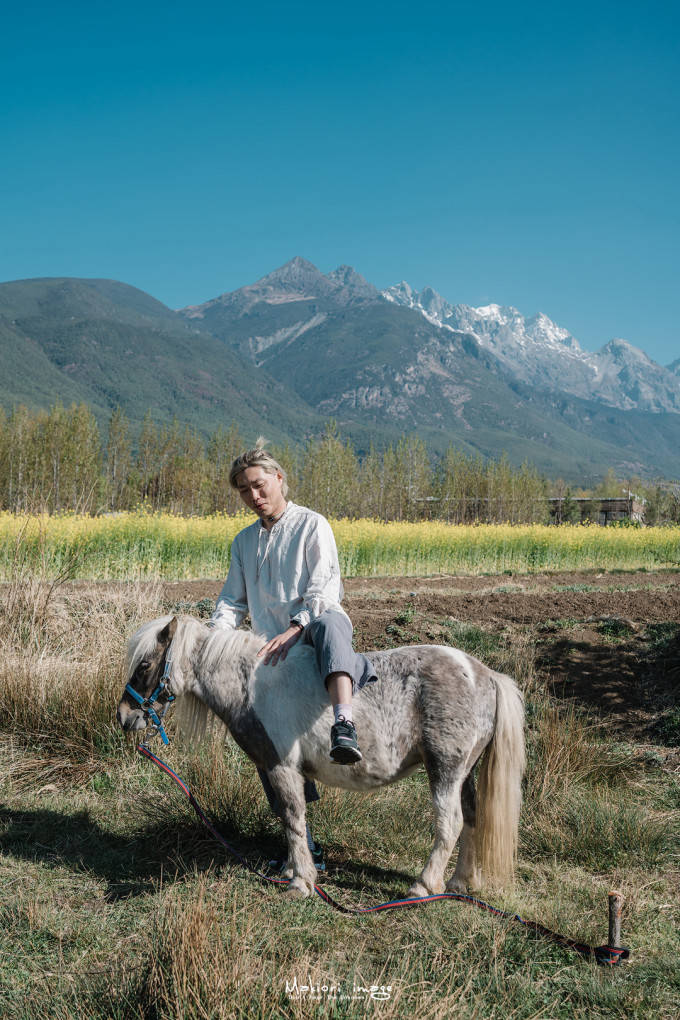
[{"x1": 382, "y1": 282, "x2": 680, "y2": 414}]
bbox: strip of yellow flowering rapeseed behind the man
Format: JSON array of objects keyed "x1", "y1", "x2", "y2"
[{"x1": 0, "y1": 512, "x2": 680, "y2": 580}]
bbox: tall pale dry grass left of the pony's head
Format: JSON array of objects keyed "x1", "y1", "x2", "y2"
[{"x1": 0, "y1": 538, "x2": 161, "y2": 786}]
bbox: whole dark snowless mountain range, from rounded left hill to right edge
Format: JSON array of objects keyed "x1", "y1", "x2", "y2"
[{"x1": 0, "y1": 267, "x2": 680, "y2": 483}]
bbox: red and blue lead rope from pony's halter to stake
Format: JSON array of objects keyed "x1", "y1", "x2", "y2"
[{"x1": 137, "y1": 744, "x2": 630, "y2": 967}]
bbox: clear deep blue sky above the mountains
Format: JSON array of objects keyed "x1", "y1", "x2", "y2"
[{"x1": 0, "y1": 0, "x2": 680, "y2": 364}]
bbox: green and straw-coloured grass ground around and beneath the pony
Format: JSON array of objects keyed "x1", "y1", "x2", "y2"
[{"x1": 0, "y1": 558, "x2": 680, "y2": 1020}]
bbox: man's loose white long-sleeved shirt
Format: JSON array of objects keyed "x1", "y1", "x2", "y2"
[{"x1": 212, "y1": 503, "x2": 345, "y2": 640}]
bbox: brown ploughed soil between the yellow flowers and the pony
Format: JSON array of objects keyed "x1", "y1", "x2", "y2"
[{"x1": 158, "y1": 570, "x2": 680, "y2": 757}]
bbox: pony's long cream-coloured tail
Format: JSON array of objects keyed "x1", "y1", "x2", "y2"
[{"x1": 475, "y1": 673, "x2": 525, "y2": 884}]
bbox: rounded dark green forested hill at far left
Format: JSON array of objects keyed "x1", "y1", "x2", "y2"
[{"x1": 0, "y1": 278, "x2": 316, "y2": 438}]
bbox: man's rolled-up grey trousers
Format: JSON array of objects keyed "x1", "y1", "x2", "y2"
[{"x1": 258, "y1": 609, "x2": 377, "y2": 815}]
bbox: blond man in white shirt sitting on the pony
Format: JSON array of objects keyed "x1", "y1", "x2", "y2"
[{"x1": 211, "y1": 440, "x2": 375, "y2": 866}]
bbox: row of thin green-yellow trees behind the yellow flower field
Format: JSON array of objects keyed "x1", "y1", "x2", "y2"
[{"x1": 0, "y1": 404, "x2": 680, "y2": 523}]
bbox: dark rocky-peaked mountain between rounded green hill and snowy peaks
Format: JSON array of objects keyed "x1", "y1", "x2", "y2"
[{"x1": 174, "y1": 261, "x2": 680, "y2": 473}]
